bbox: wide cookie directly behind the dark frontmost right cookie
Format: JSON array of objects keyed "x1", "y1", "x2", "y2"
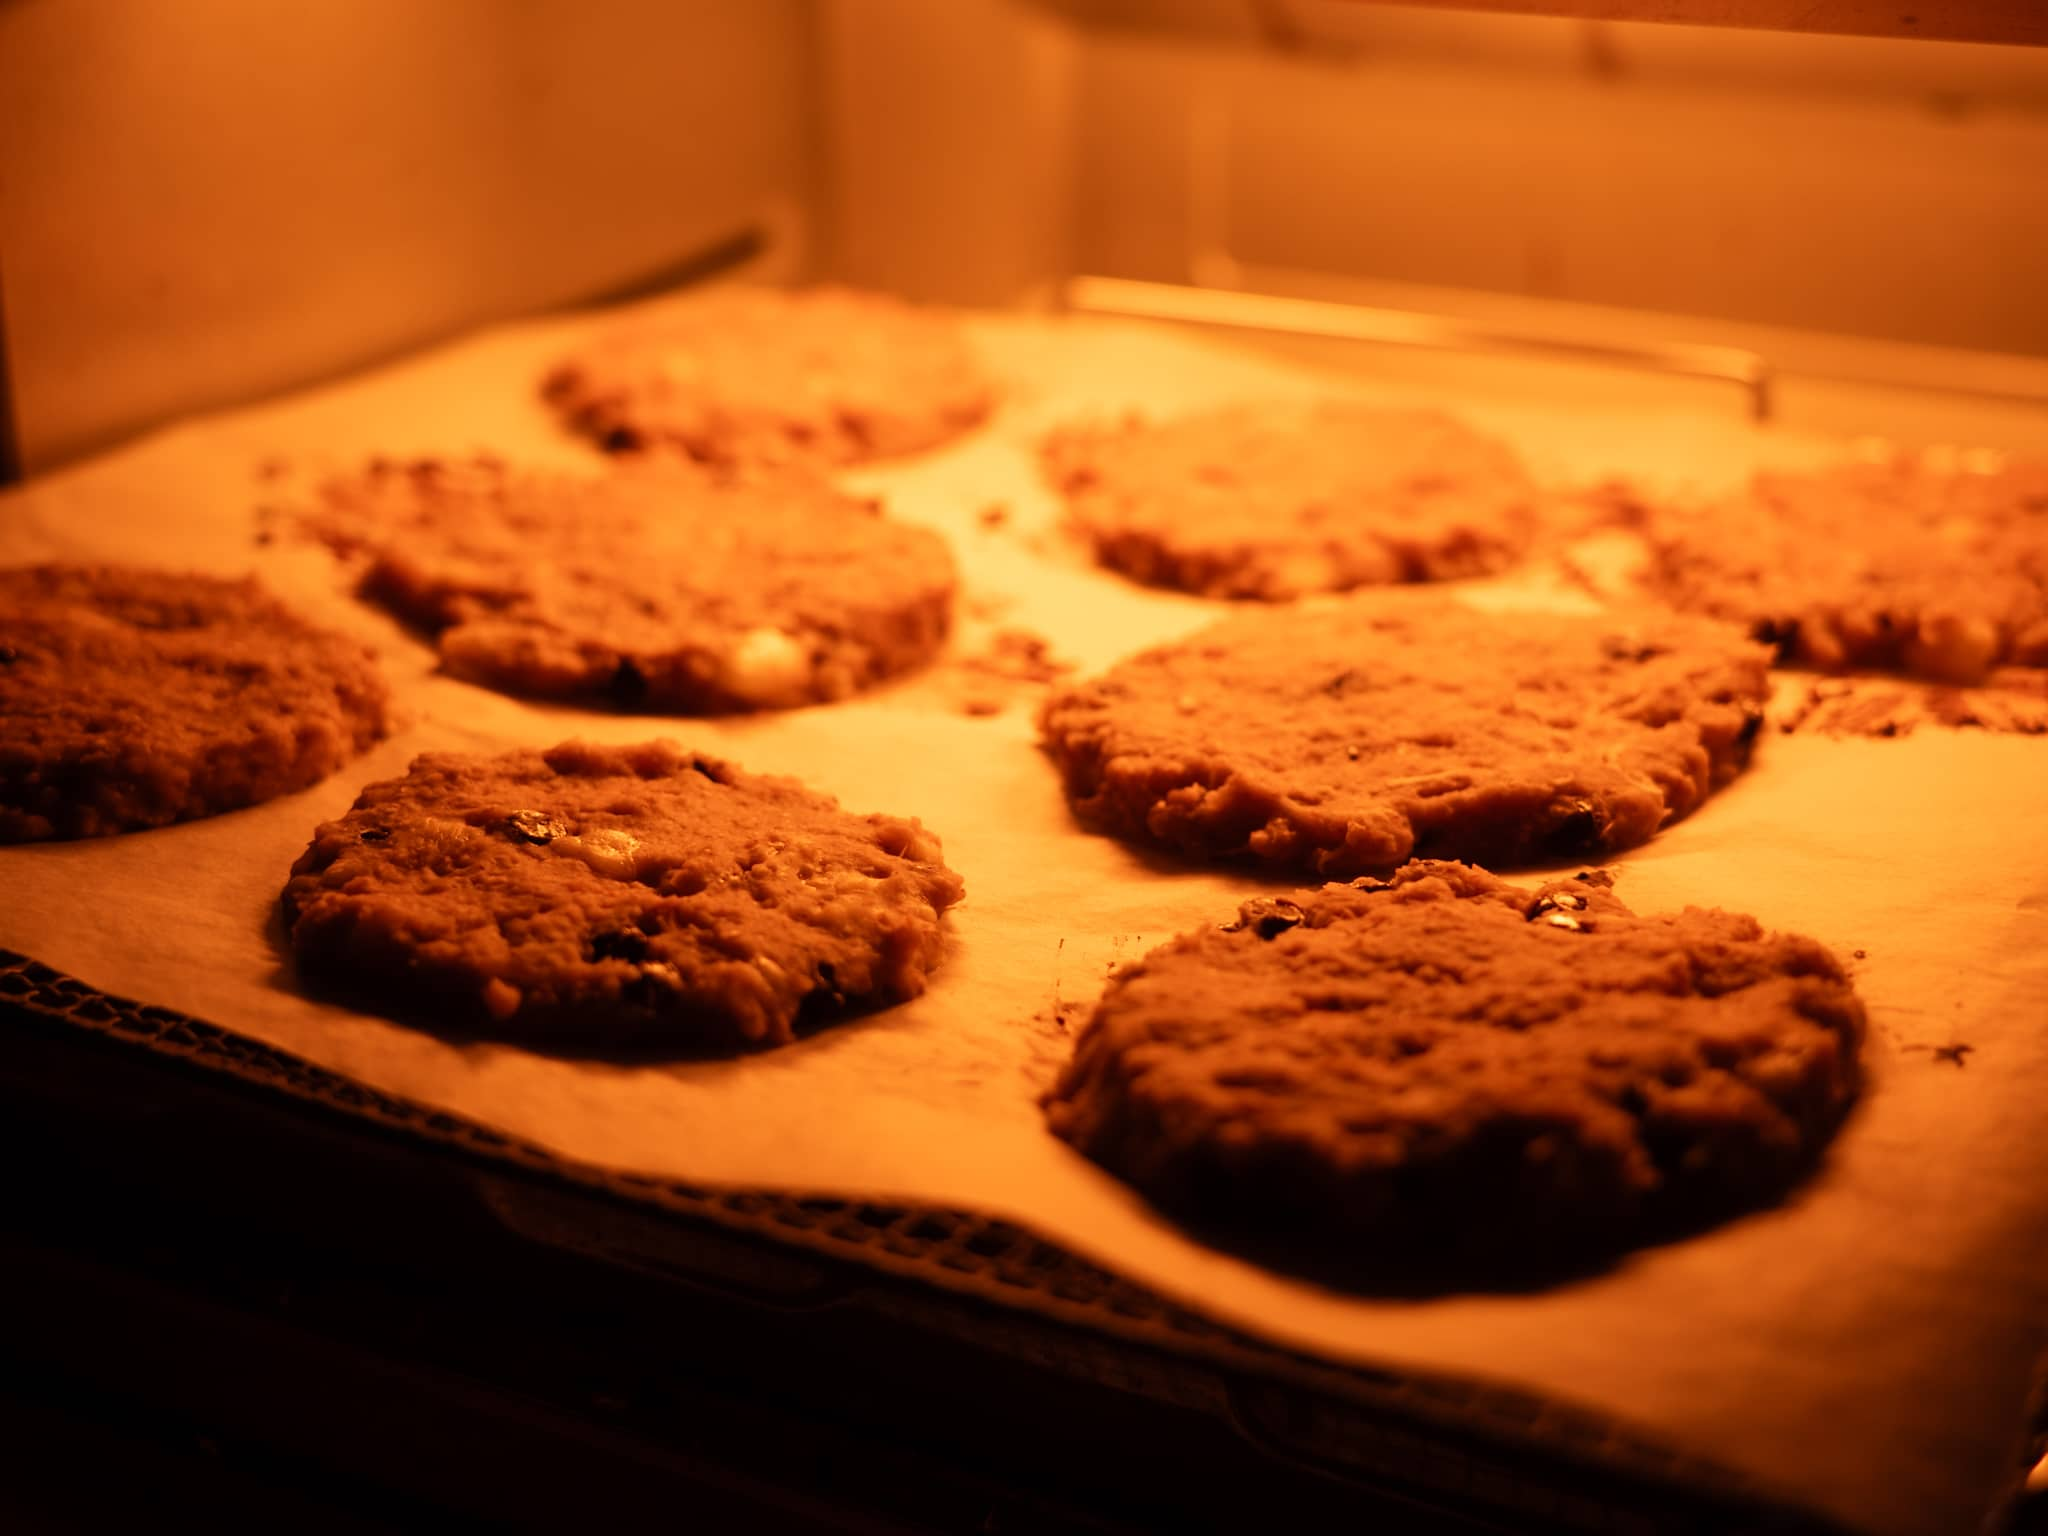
[{"x1": 1040, "y1": 592, "x2": 1769, "y2": 879}]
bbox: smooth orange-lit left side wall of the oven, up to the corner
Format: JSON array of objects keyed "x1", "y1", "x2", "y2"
[{"x1": 0, "y1": 0, "x2": 815, "y2": 471}]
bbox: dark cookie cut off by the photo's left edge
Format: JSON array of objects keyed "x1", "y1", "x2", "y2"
[{"x1": 0, "y1": 565, "x2": 391, "y2": 842}]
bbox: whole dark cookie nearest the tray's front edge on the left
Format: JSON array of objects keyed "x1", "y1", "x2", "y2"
[{"x1": 285, "y1": 741, "x2": 963, "y2": 1051}]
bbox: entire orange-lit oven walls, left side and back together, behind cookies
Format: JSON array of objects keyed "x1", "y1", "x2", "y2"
[{"x1": 0, "y1": 0, "x2": 2048, "y2": 473}]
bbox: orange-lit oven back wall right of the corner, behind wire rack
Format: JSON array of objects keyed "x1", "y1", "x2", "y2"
[{"x1": 1077, "y1": 6, "x2": 2048, "y2": 354}]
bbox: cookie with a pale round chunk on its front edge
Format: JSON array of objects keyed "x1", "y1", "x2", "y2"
[{"x1": 303, "y1": 459, "x2": 954, "y2": 715}]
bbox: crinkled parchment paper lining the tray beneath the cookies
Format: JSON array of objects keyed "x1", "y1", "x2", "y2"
[{"x1": 0, "y1": 301, "x2": 2048, "y2": 1536}]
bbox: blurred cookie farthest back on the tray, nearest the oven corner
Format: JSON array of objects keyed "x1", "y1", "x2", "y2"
[{"x1": 541, "y1": 289, "x2": 995, "y2": 465}]
